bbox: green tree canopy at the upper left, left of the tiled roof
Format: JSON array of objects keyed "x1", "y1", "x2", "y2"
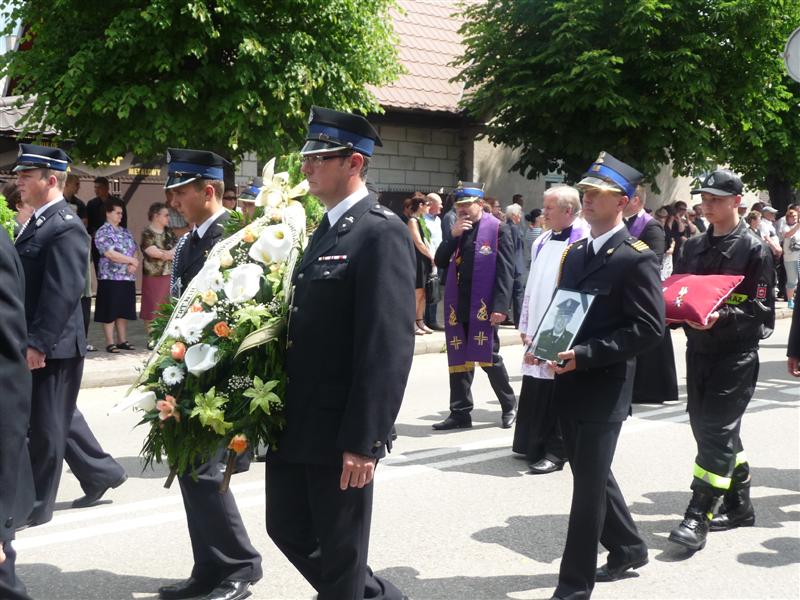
[{"x1": 0, "y1": 0, "x2": 400, "y2": 161}]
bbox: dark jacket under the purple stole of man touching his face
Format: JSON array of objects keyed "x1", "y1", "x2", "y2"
[{"x1": 434, "y1": 217, "x2": 514, "y2": 323}]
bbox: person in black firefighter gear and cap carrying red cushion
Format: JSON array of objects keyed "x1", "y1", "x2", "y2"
[{"x1": 669, "y1": 169, "x2": 775, "y2": 550}]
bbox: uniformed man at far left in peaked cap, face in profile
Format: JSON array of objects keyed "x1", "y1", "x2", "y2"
[{"x1": 14, "y1": 144, "x2": 89, "y2": 524}]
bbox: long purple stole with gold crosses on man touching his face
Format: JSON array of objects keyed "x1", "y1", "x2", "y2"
[{"x1": 444, "y1": 213, "x2": 500, "y2": 373}]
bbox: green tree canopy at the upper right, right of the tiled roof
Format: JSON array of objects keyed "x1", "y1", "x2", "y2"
[{"x1": 460, "y1": 0, "x2": 796, "y2": 203}]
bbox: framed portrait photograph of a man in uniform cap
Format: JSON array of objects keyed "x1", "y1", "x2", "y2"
[{"x1": 526, "y1": 288, "x2": 594, "y2": 362}]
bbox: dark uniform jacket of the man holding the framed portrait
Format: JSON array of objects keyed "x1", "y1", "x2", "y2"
[{"x1": 555, "y1": 228, "x2": 664, "y2": 423}]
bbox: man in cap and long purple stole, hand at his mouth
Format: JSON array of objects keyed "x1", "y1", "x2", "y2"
[{"x1": 433, "y1": 183, "x2": 517, "y2": 431}]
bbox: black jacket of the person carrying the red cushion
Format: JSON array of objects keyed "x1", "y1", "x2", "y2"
[{"x1": 675, "y1": 220, "x2": 775, "y2": 353}]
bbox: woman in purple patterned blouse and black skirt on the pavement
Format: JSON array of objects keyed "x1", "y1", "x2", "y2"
[{"x1": 94, "y1": 197, "x2": 139, "y2": 353}]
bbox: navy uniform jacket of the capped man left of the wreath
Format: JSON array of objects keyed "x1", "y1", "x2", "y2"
[{"x1": 15, "y1": 199, "x2": 90, "y2": 359}]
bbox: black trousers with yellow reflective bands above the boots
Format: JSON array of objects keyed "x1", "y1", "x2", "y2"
[{"x1": 686, "y1": 350, "x2": 759, "y2": 495}]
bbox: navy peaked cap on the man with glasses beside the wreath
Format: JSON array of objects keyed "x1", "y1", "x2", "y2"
[{"x1": 300, "y1": 106, "x2": 383, "y2": 156}]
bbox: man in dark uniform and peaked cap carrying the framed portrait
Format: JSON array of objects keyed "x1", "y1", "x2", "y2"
[{"x1": 549, "y1": 152, "x2": 664, "y2": 600}]
